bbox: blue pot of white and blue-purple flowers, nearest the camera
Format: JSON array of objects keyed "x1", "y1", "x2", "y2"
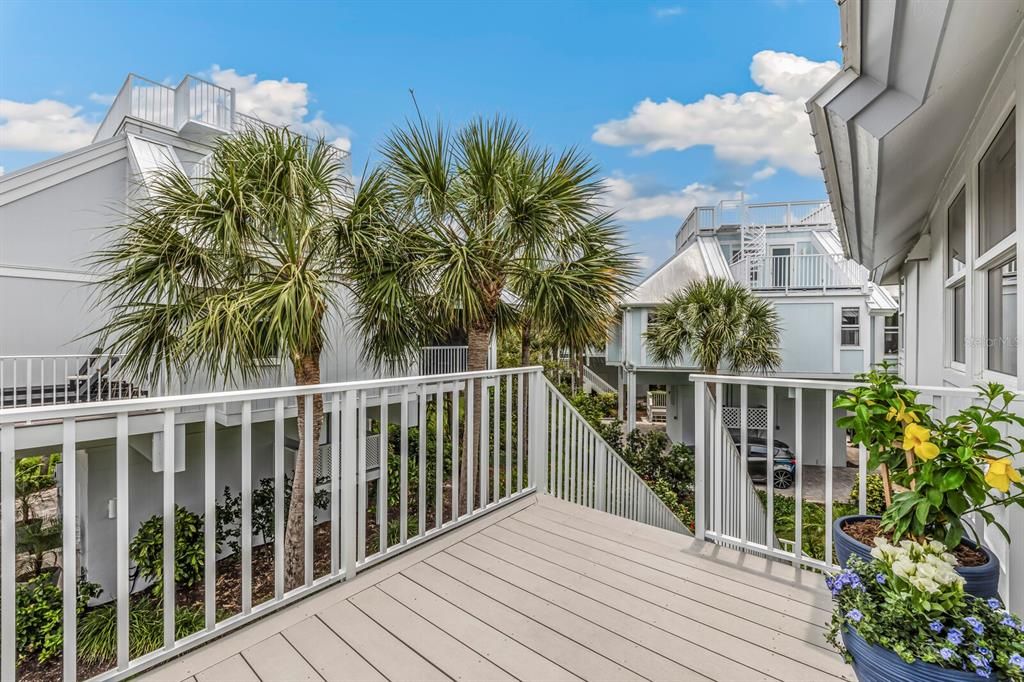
[{"x1": 825, "y1": 538, "x2": 1024, "y2": 682}]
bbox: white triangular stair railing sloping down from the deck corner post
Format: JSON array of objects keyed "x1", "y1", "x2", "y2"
[{"x1": 538, "y1": 380, "x2": 689, "y2": 534}]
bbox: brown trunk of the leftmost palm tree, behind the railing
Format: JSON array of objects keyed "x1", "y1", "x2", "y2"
[{"x1": 285, "y1": 351, "x2": 324, "y2": 590}]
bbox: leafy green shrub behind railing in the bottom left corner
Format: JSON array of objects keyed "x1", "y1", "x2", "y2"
[{"x1": 14, "y1": 574, "x2": 100, "y2": 663}]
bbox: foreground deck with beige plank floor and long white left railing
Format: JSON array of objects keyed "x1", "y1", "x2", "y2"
[{"x1": 0, "y1": 368, "x2": 853, "y2": 680}]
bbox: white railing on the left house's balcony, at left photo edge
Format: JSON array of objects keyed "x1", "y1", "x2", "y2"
[{"x1": 0, "y1": 354, "x2": 148, "y2": 410}]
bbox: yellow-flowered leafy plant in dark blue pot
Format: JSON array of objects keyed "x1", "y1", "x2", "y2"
[{"x1": 834, "y1": 365, "x2": 1024, "y2": 597}]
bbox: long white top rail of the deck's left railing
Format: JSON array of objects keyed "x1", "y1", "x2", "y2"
[{"x1": 0, "y1": 366, "x2": 544, "y2": 424}]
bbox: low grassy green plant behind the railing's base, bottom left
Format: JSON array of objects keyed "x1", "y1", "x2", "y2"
[{"x1": 78, "y1": 597, "x2": 206, "y2": 664}]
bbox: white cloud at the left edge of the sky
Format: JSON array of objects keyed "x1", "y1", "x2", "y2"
[{"x1": 0, "y1": 99, "x2": 97, "y2": 152}]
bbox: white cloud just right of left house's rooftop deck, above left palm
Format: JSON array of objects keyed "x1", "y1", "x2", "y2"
[{"x1": 210, "y1": 65, "x2": 352, "y2": 152}]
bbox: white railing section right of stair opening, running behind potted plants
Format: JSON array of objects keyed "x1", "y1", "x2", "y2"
[{"x1": 690, "y1": 375, "x2": 1024, "y2": 577}]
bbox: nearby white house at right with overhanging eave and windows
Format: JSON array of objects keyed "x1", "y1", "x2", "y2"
[{"x1": 807, "y1": 0, "x2": 1024, "y2": 610}]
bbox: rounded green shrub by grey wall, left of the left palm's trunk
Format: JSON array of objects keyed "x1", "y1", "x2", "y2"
[{"x1": 128, "y1": 505, "x2": 206, "y2": 595}]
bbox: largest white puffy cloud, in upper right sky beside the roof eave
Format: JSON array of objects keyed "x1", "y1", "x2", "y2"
[{"x1": 593, "y1": 50, "x2": 839, "y2": 176}]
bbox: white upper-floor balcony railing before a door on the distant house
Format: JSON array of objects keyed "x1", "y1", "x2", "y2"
[{"x1": 729, "y1": 254, "x2": 868, "y2": 292}]
